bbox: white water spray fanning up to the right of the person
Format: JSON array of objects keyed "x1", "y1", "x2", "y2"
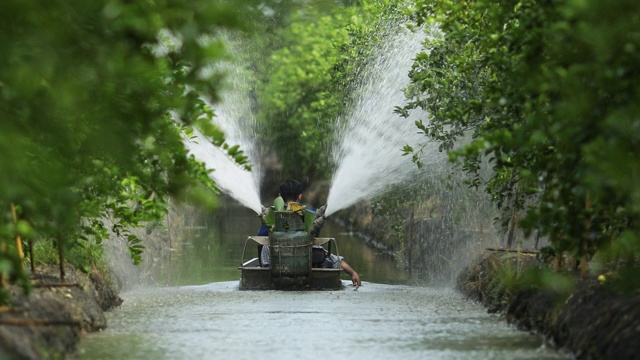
[{"x1": 326, "y1": 25, "x2": 444, "y2": 215}]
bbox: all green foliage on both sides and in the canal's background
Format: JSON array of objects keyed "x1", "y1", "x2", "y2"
[{"x1": 0, "y1": 0, "x2": 640, "y2": 304}]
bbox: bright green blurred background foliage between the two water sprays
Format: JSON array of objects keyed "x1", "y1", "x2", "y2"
[{"x1": 258, "y1": 1, "x2": 397, "y2": 179}]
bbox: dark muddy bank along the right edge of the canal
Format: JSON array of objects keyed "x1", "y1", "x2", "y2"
[{"x1": 457, "y1": 253, "x2": 640, "y2": 359}]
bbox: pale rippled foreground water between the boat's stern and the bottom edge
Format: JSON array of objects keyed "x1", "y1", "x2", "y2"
[{"x1": 79, "y1": 281, "x2": 559, "y2": 359}]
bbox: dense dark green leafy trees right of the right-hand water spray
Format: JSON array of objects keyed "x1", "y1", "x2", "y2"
[{"x1": 404, "y1": 0, "x2": 640, "y2": 275}]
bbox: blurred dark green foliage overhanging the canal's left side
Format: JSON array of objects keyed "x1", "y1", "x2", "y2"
[{"x1": 0, "y1": 0, "x2": 248, "y2": 298}]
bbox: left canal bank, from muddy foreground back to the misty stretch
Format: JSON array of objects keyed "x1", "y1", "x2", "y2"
[{"x1": 0, "y1": 208, "x2": 180, "y2": 360}]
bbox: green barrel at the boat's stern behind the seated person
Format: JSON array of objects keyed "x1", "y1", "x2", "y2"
[{"x1": 269, "y1": 211, "x2": 313, "y2": 285}]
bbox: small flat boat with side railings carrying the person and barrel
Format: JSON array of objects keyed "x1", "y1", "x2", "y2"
[{"x1": 239, "y1": 236, "x2": 343, "y2": 290}]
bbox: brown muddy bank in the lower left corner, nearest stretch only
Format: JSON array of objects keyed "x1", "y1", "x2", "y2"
[{"x1": 0, "y1": 267, "x2": 122, "y2": 359}]
